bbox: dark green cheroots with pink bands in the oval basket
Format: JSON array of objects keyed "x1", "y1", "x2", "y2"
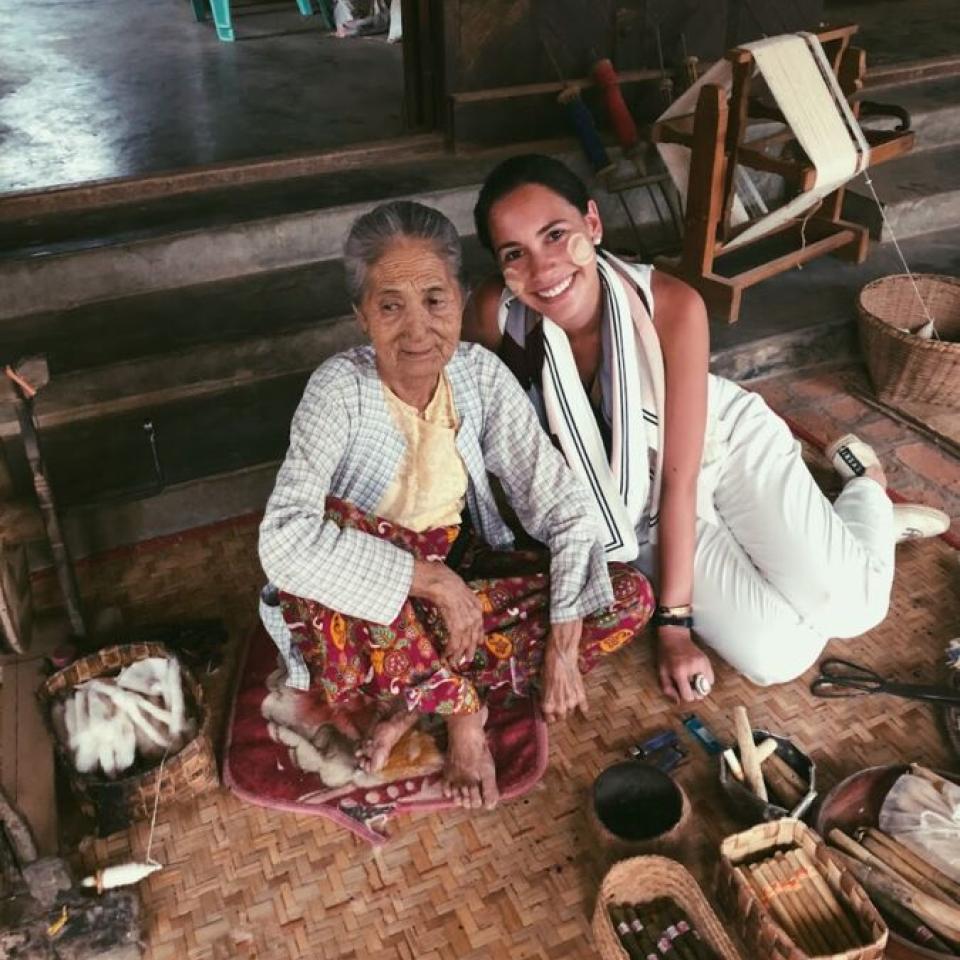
[{"x1": 607, "y1": 898, "x2": 717, "y2": 960}]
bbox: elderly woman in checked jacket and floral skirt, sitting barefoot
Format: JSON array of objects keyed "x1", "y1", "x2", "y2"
[{"x1": 260, "y1": 202, "x2": 652, "y2": 807}]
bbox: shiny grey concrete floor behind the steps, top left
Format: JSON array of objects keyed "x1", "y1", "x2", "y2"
[{"x1": 0, "y1": 0, "x2": 403, "y2": 193}]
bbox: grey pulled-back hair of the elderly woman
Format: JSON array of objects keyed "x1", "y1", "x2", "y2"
[{"x1": 343, "y1": 200, "x2": 463, "y2": 303}]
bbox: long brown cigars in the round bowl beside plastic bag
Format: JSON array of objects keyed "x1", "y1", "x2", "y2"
[{"x1": 827, "y1": 765, "x2": 960, "y2": 956}]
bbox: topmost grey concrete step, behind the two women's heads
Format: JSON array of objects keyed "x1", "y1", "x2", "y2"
[{"x1": 0, "y1": 144, "x2": 684, "y2": 326}]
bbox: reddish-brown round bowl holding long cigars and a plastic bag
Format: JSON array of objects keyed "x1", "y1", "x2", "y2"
[{"x1": 817, "y1": 763, "x2": 956, "y2": 960}]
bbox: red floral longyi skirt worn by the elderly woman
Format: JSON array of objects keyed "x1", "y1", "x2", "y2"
[{"x1": 280, "y1": 497, "x2": 654, "y2": 715}]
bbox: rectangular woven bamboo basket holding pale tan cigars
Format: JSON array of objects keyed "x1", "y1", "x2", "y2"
[{"x1": 718, "y1": 818, "x2": 888, "y2": 960}]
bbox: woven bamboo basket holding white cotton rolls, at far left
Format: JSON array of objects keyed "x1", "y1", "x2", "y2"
[{"x1": 38, "y1": 643, "x2": 219, "y2": 837}]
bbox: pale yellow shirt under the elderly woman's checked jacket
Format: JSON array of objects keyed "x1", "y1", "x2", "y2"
[{"x1": 376, "y1": 374, "x2": 467, "y2": 533}]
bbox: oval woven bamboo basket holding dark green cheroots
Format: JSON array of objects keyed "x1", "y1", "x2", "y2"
[{"x1": 593, "y1": 856, "x2": 741, "y2": 960}]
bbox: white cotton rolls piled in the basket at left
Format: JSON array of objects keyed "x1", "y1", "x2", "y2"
[{"x1": 52, "y1": 657, "x2": 197, "y2": 779}]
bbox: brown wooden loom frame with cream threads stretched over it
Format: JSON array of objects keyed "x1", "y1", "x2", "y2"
[{"x1": 652, "y1": 25, "x2": 914, "y2": 323}]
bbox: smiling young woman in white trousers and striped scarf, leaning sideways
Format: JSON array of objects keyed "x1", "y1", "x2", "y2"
[{"x1": 464, "y1": 155, "x2": 949, "y2": 701}]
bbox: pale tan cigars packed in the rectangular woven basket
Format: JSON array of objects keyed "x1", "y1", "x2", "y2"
[{"x1": 734, "y1": 847, "x2": 864, "y2": 957}]
